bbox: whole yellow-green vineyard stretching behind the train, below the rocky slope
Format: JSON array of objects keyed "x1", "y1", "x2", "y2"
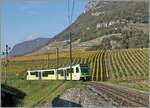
[{"x1": 2, "y1": 49, "x2": 149, "y2": 81}]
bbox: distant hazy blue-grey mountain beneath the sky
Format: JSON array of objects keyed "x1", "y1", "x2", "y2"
[{"x1": 10, "y1": 38, "x2": 50, "y2": 56}]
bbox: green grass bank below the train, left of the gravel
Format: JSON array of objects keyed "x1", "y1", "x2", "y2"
[{"x1": 4, "y1": 76, "x2": 82, "y2": 107}]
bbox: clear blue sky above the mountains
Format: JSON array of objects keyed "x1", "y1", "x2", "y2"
[{"x1": 1, "y1": 0, "x2": 87, "y2": 49}]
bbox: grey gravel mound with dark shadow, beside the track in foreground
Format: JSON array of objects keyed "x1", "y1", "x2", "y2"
[{"x1": 47, "y1": 87, "x2": 118, "y2": 108}]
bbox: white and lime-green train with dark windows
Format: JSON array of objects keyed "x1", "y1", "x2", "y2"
[{"x1": 26, "y1": 64, "x2": 90, "y2": 80}]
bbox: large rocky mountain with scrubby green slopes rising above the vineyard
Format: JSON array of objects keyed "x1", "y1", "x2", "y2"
[{"x1": 30, "y1": 0, "x2": 149, "y2": 53}]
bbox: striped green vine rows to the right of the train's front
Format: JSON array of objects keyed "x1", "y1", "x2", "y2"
[{"x1": 88, "y1": 49, "x2": 149, "y2": 81}]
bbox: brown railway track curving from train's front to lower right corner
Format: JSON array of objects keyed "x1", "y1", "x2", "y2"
[{"x1": 86, "y1": 82, "x2": 149, "y2": 107}]
